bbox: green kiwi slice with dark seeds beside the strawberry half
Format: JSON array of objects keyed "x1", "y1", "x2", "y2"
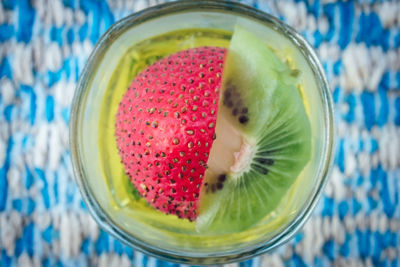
[{"x1": 196, "y1": 26, "x2": 311, "y2": 233}]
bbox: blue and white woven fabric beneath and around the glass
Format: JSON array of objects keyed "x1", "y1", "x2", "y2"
[{"x1": 0, "y1": 0, "x2": 400, "y2": 267}]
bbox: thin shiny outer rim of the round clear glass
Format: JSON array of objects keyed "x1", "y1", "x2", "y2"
[{"x1": 69, "y1": 0, "x2": 335, "y2": 264}]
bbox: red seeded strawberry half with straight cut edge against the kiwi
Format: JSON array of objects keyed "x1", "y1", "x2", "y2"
[{"x1": 116, "y1": 47, "x2": 226, "y2": 221}]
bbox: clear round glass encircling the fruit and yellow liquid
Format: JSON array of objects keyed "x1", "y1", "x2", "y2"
[{"x1": 70, "y1": 1, "x2": 334, "y2": 264}]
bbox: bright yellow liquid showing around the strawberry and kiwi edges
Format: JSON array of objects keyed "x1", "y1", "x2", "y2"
[{"x1": 98, "y1": 29, "x2": 308, "y2": 239}]
